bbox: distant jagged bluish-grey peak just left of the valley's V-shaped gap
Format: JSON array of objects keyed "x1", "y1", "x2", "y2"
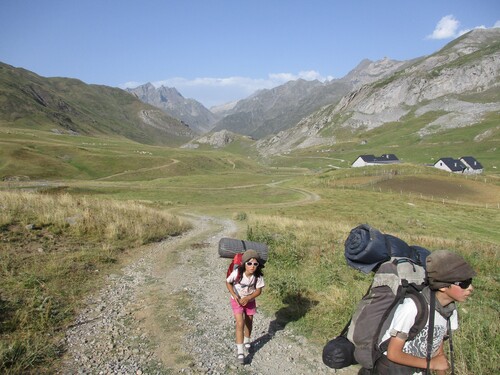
[{"x1": 126, "y1": 83, "x2": 220, "y2": 134}]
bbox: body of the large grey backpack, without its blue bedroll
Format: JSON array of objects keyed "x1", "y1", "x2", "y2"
[{"x1": 347, "y1": 257, "x2": 429, "y2": 369}]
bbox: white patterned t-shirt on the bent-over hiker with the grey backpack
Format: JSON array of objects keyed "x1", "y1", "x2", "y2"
[{"x1": 382, "y1": 298, "x2": 458, "y2": 358}]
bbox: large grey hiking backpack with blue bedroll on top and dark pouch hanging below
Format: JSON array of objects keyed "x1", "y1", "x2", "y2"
[{"x1": 323, "y1": 224, "x2": 430, "y2": 369}]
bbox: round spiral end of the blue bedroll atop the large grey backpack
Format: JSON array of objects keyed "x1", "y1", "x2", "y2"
[{"x1": 344, "y1": 224, "x2": 391, "y2": 273}]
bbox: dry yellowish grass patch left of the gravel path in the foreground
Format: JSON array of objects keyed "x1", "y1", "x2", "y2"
[{"x1": 0, "y1": 192, "x2": 190, "y2": 373}]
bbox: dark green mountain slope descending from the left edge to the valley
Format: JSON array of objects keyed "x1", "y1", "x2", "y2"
[{"x1": 0, "y1": 63, "x2": 193, "y2": 145}]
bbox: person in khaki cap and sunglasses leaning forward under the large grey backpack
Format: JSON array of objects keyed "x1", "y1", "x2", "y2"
[{"x1": 372, "y1": 250, "x2": 476, "y2": 375}]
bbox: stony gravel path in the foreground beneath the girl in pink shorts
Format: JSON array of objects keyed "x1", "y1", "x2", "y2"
[{"x1": 60, "y1": 217, "x2": 357, "y2": 375}]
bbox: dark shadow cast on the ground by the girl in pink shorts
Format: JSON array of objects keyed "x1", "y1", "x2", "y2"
[{"x1": 246, "y1": 294, "x2": 318, "y2": 363}]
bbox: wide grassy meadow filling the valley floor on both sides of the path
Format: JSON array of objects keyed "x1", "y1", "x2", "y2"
[{"x1": 0, "y1": 128, "x2": 500, "y2": 375}]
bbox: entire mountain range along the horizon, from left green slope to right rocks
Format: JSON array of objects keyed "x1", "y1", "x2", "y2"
[{"x1": 0, "y1": 28, "x2": 500, "y2": 155}]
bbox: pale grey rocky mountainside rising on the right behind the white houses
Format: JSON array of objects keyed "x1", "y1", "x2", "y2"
[{"x1": 257, "y1": 28, "x2": 500, "y2": 155}]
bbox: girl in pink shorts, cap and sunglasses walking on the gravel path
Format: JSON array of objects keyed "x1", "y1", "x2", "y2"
[{"x1": 226, "y1": 250, "x2": 265, "y2": 364}]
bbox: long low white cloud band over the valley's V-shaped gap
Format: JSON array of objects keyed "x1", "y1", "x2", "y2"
[{"x1": 120, "y1": 70, "x2": 333, "y2": 108}]
